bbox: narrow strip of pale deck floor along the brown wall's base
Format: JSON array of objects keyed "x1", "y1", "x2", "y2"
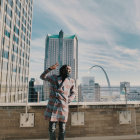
[{"x1": 20, "y1": 135, "x2": 140, "y2": 140}]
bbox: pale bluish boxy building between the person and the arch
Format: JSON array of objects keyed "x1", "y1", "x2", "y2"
[{"x1": 81, "y1": 76, "x2": 95, "y2": 102}]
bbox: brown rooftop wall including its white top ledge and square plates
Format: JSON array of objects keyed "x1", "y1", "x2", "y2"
[{"x1": 0, "y1": 101, "x2": 140, "y2": 140}]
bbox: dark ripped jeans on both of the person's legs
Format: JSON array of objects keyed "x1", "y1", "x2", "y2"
[{"x1": 49, "y1": 121, "x2": 66, "y2": 140}]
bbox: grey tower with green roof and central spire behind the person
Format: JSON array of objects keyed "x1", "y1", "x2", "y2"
[{"x1": 44, "y1": 30, "x2": 78, "y2": 100}]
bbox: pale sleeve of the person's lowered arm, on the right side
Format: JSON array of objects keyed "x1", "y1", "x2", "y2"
[{"x1": 68, "y1": 80, "x2": 76, "y2": 103}]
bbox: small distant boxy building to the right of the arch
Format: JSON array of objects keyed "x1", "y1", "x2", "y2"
[{"x1": 120, "y1": 82, "x2": 130, "y2": 101}]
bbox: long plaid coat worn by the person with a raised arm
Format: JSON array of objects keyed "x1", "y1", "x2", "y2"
[{"x1": 41, "y1": 69, "x2": 75, "y2": 122}]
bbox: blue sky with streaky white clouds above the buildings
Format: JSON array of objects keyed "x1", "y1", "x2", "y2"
[{"x1": 30, "y1": 0, "x2": 140, "y2": 86}]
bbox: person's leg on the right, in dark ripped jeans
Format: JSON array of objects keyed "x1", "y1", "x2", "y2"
[{"x1": 58, "y1": 122, "x2": 66, "y2": 140}]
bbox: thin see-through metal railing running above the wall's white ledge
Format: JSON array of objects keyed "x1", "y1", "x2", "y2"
[{"x1": 0, "y1": 86, "x2": 140, "y2": 103}]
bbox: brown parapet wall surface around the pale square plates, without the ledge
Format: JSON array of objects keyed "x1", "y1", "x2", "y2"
[{"x1": 0, "y1": 105, "x2": 140, "y2": 140}]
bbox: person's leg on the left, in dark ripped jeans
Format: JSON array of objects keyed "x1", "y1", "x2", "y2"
[{"x1": 49, "y1": 121, "x2": 57, "y2": 140}]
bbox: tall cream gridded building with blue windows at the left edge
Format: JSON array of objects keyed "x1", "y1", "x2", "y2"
[{"x1": 0, "y1": 0, "x2": 33, "y2": 103}]
